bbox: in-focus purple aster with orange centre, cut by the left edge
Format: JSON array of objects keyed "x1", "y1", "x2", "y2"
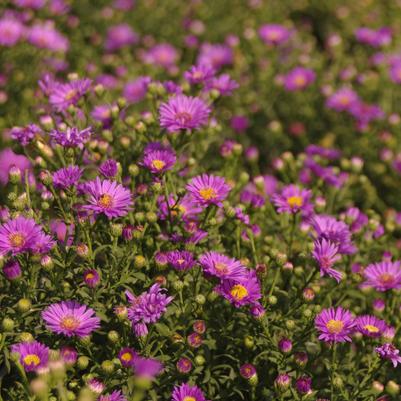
[{"x1": 0, "y1": 216, "x2": 42, "y2": 255}]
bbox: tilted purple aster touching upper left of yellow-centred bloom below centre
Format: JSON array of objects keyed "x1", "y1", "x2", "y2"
[{"x1": 199, "y1": 251, "x2": 247, "y2": 281}]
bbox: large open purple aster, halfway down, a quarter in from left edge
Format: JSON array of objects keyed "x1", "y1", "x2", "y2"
[{"x1": 83, "y1": 177, "x2": 132, "y2": 219}]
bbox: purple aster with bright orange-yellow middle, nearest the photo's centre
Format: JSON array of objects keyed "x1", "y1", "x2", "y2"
[{"x1": 186, "y1": 174, "x2": 231, "y2": 207}]
